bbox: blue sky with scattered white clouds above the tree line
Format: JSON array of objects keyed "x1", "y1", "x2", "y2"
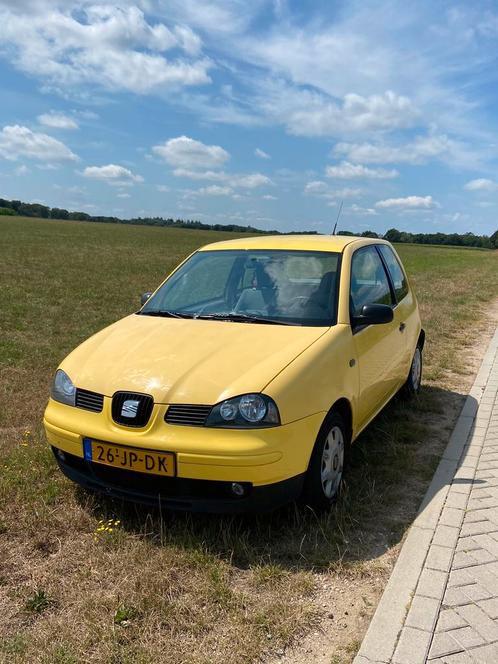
[{"x1": 0, "y1": 0, "x2": 498, "y2": 234}]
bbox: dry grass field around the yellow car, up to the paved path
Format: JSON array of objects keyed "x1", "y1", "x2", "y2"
[{"x1": 0, "y1": 218, "x2": 498, "y2": 664}]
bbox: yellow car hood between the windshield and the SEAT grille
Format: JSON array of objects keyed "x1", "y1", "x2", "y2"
[{"x1": 61, "y1": 314, "x2": 328, "y2": 404}]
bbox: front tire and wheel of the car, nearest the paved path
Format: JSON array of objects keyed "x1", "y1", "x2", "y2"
[{"x1": 301, "y1": 412, "x2": 349, "y2": 512}]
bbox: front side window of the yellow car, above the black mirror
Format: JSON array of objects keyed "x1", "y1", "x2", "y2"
[{"x1": 351, "y1": 246, "x2": 393, "y2": 316}]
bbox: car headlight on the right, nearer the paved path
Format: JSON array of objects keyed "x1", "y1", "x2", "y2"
[{"x1": 206, "y1": 394, "x2": 280, "y2": 429}]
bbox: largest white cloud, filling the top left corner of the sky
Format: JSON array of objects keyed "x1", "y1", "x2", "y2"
[{"x1": 0, "y1": 2, "x2": 211, "y2": 94}]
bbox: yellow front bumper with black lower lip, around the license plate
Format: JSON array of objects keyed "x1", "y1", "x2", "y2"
[{"x1": 44, "y1": 399, "x2": 324, "y2": 512}]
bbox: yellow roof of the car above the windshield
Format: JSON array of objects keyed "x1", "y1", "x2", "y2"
[{"x1": 200, "y1": 235, "x2": 387, "y2": 252}]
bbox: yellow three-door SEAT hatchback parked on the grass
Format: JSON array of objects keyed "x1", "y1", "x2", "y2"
[{"x1": 44, "y1": 235, "x2": 425, "y2": 512}]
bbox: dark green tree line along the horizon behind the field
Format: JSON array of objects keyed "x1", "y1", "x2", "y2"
[{"x1": 0, "y1": 198, "x2": 498, "y2": 249}]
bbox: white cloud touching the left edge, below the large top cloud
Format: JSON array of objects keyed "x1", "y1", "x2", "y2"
[{"x1": 0, "y1": 125, "x2": 78, "y2": 164}]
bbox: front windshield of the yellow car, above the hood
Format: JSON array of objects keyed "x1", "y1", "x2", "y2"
[{"x1": 139, "y1": 250, "x2": 339, "y2": 326}]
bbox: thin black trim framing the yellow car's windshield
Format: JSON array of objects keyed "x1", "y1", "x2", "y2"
[{"x1": 140, "y1": 247, "x2": 343, "y2": 328}]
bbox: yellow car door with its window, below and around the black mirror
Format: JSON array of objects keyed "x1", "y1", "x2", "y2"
[{"x1": 350, "y1": 244, "x2": 405, "y2": 428}]
